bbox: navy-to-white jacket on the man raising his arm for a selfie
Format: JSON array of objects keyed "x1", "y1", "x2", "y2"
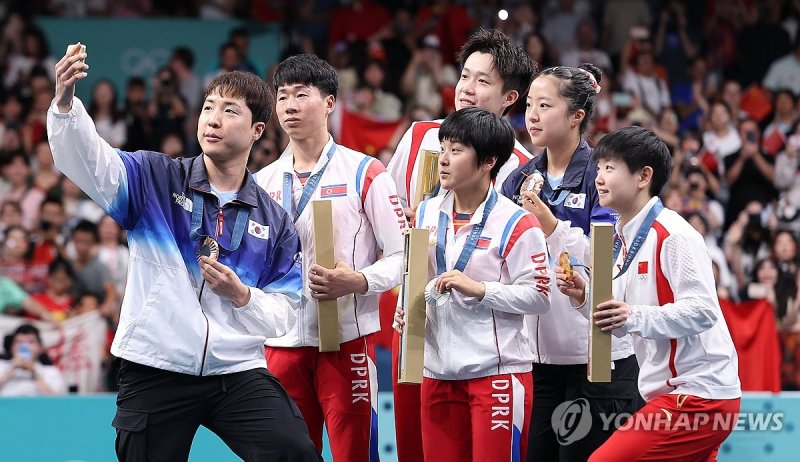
[{"x1": 47, "y1": 98, "x2": 302, "y2": 375}]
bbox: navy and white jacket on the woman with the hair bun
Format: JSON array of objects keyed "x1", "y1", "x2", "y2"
[{"x1": 502, "y1": 140, "x2": 633, "y2": 364}]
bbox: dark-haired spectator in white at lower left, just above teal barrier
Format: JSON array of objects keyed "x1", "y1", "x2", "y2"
[{"x1": 0, "y1": 324, "x2": 67, "y2": 396}]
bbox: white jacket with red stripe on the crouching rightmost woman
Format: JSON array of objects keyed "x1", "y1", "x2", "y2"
[{"x1": 592, "y1": 198, "x2": 742, "y2": 401}]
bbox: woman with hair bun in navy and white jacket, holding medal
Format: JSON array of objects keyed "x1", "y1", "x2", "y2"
[{"x1": 502, "y1": 64, "x2": 641, "y2": 461}]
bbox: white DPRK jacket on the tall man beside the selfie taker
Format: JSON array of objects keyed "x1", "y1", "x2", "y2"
[{"x1": 255, "y1": 138, "x2": 407, "y2": 347}]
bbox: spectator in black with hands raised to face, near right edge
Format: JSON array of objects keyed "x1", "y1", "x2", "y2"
[{"x1": 723, "y1": 120, "x2": 778, "y2": 228}]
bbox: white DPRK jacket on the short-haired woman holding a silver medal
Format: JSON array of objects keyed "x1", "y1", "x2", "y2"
[{"x1": 416, "y1": 186, "x2": 550, "y2": 380}]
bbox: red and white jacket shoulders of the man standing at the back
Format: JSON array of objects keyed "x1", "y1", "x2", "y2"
[{"x1": 387, "y1": 119, "x2": 533, "y2": 208}]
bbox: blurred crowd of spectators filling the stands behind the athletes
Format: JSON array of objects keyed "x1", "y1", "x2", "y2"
[{"x1": 0, "y1": 0, "x2": 800, "y2": 394}]
